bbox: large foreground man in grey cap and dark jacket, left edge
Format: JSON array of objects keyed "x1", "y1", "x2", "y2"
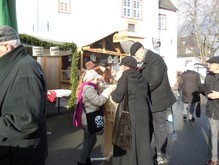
[{"x1": 0, "y1": 25, "x2": 48, "y2": 165}]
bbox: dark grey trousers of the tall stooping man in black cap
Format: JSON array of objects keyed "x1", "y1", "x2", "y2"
[{"x1": 152, "y1": 110, "x2": 167, "y2": 155}]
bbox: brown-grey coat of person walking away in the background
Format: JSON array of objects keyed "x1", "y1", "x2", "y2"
[{"x1": 179, "y1": 70, "x2": 202, "y2": 103}]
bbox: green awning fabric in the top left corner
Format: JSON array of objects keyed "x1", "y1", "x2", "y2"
[{"x1": 0, "y1": 0, "x2": 17, "y2": 30}]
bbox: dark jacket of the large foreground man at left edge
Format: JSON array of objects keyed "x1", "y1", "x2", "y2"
[{"x1": 0, "y1": 45, "x2": 47, "y2": 157}]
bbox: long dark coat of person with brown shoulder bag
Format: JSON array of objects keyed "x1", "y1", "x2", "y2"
[{"x1": 111, "y1": 69, "x2": 153, "y2": 165}]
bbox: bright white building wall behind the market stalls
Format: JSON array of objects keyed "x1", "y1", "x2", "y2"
[{"x1": 17, "y1": 0, "x2": 177, "y2": 85}]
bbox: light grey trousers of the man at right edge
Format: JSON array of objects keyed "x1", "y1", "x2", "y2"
[{"x1": 208, "y1": 118, "x2": 219, "y2": 161}]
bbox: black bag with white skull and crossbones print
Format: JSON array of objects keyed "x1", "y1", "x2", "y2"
[{"x1": 82, "y1": 103, "x2": 104, "y2": 133}]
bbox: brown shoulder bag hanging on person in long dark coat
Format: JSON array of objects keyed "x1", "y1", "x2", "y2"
[{"x1": 112, "y1": 77, "x2": 132, "y2": 150}]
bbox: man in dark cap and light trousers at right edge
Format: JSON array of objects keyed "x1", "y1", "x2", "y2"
[{"x1": 204, "y1": 56, "x2": 219, "y2": 165}]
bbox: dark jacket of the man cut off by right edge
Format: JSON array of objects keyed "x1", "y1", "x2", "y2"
[{"x1": 204, "y1": 73, "x2": 219, "y2": 120}]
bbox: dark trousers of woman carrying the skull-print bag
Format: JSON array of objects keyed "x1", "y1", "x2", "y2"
[{"x1": 79, "y1": 125, "x2": 97, "y2": 163}]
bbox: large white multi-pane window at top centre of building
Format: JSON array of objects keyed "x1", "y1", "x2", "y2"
[{"x1": 122, "y1": 0, "x2": 142, "y2": 19}]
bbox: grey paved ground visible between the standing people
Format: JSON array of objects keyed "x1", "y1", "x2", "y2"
[{"x1": 47, "y1": 96, "x2": 208, "y2": 165}]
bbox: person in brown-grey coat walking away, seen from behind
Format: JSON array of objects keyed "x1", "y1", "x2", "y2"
[{"x1": 178, "y1": 62, "x2": 202, "y2": 121}]
